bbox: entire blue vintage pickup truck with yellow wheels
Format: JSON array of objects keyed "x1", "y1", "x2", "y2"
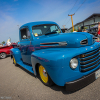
[{"x1": 11, "y1": 21, "x2": 100, "y2": 91}]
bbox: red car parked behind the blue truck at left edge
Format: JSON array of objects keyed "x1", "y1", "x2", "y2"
[{"x1": 0, "y1": 44, "x2": 17, "y2": 59}]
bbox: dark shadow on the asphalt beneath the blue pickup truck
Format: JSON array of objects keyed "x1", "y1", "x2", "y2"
[{"x1": 17, "y1": 65, "x2": 79, "y2": 94}]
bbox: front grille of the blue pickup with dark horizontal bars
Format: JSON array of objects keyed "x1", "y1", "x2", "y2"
[{"x1": 79, "y1": 49, "x2": 100, "y2": 72}]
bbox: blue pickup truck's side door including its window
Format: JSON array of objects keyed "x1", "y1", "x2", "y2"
[{"x1": 20, "y1": 28, "x2": 33, "y2": 65}]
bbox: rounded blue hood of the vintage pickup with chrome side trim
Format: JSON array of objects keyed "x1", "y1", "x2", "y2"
[{"x1": 33, "y1": 32, "x2": 94, "y2": 48}]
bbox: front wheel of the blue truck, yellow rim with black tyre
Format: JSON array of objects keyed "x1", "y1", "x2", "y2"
[{"x1": 39, "y1": 65, "x2": 53, "y2": 86}]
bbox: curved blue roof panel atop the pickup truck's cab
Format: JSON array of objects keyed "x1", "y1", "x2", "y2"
[{"x1": 20, "y1": 21, "x2": 56, "y2": 28}]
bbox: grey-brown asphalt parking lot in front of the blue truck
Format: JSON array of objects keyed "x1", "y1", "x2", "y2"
[{"x1": 0, "y1": 57, "x2": 100, "y2": 100}]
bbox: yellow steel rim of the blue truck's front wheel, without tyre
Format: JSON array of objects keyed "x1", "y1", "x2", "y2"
[{"x1": 39, "y1": 65, "x2": 48, "y2": 84}]
